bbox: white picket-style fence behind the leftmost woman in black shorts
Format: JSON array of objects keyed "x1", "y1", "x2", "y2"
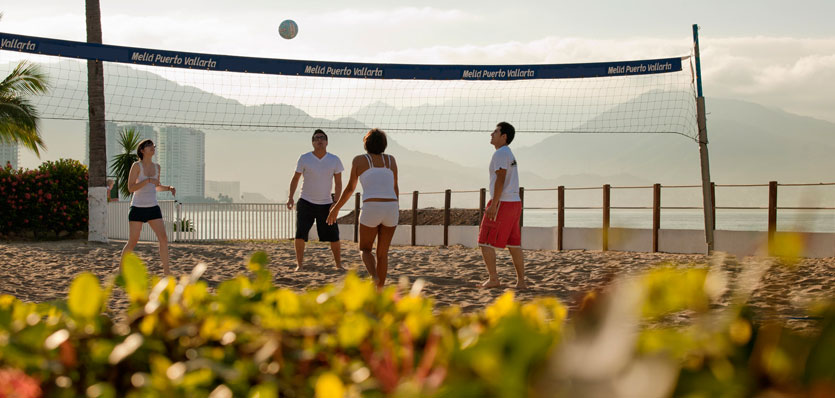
[{"x1": 107, "y1": 201, "x2": 296, "y2": 242}]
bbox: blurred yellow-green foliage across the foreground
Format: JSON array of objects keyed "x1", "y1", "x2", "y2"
[{"x1": 0, "y1": 253, "x2": 835, "y2": 398}]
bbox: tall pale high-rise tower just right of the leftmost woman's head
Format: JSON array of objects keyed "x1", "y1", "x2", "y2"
[{"x1": 156, "y1": 126, "x2": 206, "y2": 200}]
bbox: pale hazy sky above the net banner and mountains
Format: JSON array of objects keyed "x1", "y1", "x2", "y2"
[{"x1": 0, "y1": 0, "x2": 835, "y2": 190}]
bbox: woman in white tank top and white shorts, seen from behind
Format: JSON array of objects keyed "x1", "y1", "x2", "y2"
[{"x1": 328, "y1": 129, "x2": 400, "y2": 288}]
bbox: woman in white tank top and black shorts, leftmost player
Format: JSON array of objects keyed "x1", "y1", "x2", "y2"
[{"x1": 121, "y1": 140, "x2": 177, "y2": 275}]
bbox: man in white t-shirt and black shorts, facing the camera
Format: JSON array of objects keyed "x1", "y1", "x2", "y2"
[{"x1": 287, "y1": 129, "x2": 344, "y2": 271}]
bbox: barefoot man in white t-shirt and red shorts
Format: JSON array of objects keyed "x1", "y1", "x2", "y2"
[{"x1": 478, "y1": 122, "x2": 528, "y2": 290}]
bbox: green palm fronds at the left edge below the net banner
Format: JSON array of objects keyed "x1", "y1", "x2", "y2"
[{"x1": 0, "y1": 61, "x2": 48, "y2": 157}]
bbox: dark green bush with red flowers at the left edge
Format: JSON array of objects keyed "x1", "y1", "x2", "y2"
[{"x1": 0, "y1": 159, "x2": 88, "y2": 237}]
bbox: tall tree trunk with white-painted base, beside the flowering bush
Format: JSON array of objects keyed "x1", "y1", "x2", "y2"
[{"x1": 86, "y1": 0, "x2": 107, "y2": 242}]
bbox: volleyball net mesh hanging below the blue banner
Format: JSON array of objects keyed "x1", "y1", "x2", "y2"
[{"x1": 0, "y1": 51, "x2": 698, "y2": 139}]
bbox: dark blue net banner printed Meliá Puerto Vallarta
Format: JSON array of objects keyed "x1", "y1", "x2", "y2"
[{"x1": 0, "y1": 33, "x2": 686, "y2": 80}]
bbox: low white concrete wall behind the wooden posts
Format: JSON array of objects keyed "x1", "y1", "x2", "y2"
[{"x1": 334, "y1": 225, "x2": 835, "y2": 258}]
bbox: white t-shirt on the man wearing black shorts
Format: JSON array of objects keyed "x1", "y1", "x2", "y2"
[{"x1": 296, "y1": 152, "x2": 345, "y2": 205}]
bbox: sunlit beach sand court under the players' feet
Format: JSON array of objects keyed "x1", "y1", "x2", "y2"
[{"x1": 0, "y1": 240, "x2": 835, "y2": 328}]
